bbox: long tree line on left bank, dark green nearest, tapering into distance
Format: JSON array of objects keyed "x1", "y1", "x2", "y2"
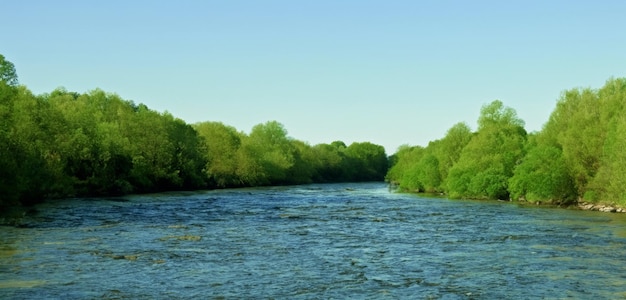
[{"x1": 0, "y1": 55, "x2": 388, "y2": 208}]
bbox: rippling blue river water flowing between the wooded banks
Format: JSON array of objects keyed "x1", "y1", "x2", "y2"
[{"x1": 0, "y1": 183, "x2": 626, "y2": 299}]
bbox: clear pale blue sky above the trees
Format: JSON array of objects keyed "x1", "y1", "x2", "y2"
[{"x1": 0, "y1": 0, "x2": 626, "y2": 154}]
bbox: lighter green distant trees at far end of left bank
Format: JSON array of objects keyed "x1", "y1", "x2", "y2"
[{"x1": 194, "y1": 121, "x2": 388, "y2": 187}]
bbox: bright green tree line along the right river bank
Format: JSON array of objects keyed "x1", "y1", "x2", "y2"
[{"x1": 386, "y1": 78, "x2": 626, "y2": 206}]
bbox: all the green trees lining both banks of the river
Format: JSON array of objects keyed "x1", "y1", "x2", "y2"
[{"x1": 0, "y1": 55, "x2": 626, "y2": 211}]
